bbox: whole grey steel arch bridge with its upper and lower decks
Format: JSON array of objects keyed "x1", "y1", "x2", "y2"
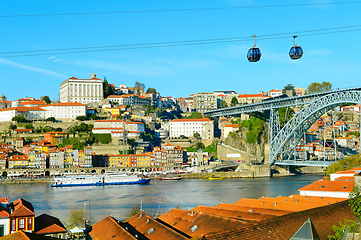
[{"x1": 205, "y1": 88, "x2": 361, "y2": 166}]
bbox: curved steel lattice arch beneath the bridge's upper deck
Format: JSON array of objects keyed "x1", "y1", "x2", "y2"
[{"x1": 269, "y1": 90, "x2": 361, "y2": 165}]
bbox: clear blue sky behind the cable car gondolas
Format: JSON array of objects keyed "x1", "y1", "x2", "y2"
[{"x1": 0, "y1": 0, "x2": 361, "y2": 100}]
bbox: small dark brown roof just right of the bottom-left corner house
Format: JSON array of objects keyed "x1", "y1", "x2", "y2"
[{"x1": 35, "y1": 213, "x2": 67, "y2": 234}]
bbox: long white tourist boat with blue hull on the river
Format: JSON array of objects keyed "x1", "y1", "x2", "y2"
[{"x1": 51, "y1": 174, "x2": 150, "y2": 187}]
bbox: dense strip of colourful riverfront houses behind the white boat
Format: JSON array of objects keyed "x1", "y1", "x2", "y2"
[{"x1": 0, "y1": 132, "x2": 208, "y2": 171}]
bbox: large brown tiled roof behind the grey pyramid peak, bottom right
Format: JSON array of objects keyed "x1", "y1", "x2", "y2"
[{"x1": 202, "y1": 200, "x2": 355, "y2": 240}]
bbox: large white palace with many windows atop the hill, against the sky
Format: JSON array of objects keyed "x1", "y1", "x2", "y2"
[{"x1": 60, "y1": 73, "x2": 103, "y2": 104}]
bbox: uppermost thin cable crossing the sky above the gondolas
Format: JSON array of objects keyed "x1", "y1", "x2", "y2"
[{"x1": 0, "y1": 1, "x2": 361, "y2": 18}]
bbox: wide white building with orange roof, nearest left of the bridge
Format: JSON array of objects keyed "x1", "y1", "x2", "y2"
[{"x1": 169, "y1": 118, "x2": 214, "y2": 139}]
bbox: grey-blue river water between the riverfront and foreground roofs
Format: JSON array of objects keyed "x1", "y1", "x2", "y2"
[{"x1": 0, "y1": 175, "x2": 322, "y2": 223}]
